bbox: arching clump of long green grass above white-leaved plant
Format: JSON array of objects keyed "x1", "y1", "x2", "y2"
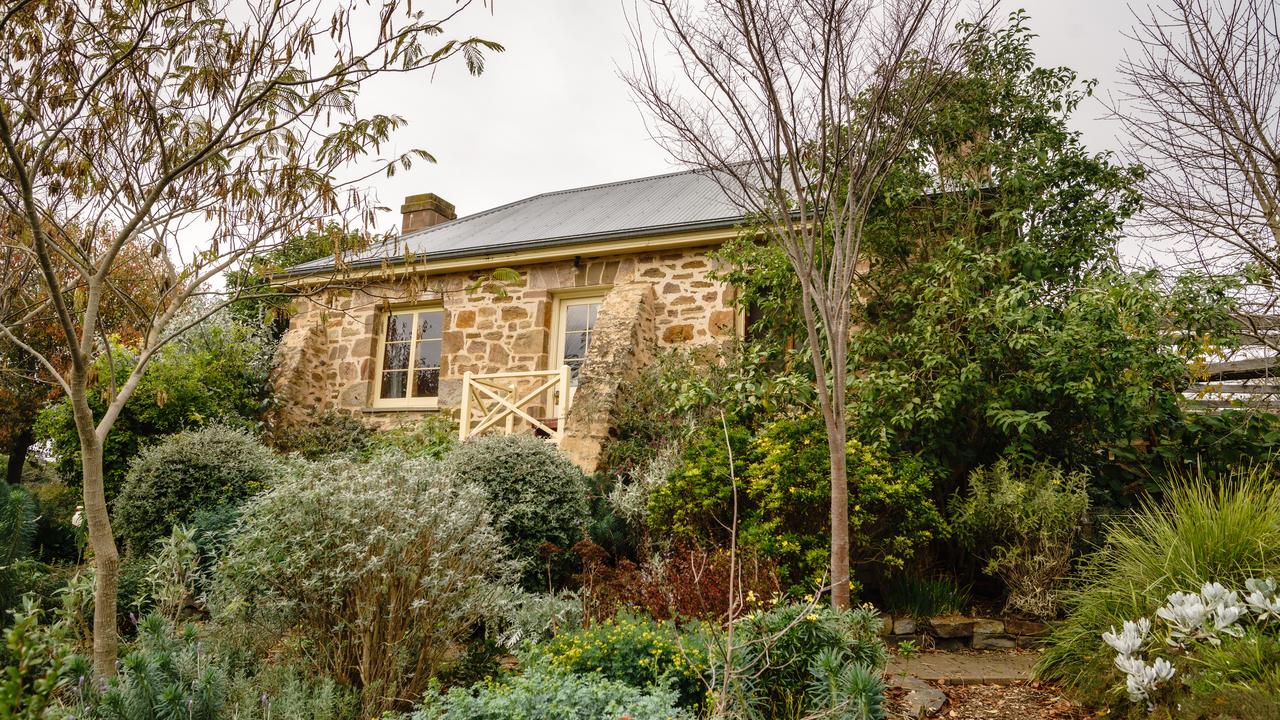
[{"x1": 1037, "y1": 465, "x2": 1280, "y2": 703}]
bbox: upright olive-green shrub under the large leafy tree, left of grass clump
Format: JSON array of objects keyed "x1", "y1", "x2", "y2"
[{"x1": 950, "y1": 460, "x2": 1089, "y2": 619}]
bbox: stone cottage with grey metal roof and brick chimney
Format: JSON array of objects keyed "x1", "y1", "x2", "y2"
[{"x1": 274, "y1": 172, "x2": 742, "y2": 471}]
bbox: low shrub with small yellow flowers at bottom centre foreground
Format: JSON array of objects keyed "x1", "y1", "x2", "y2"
[{"x1": 522, "y1": 615, "x2": 707, "y2": 707}]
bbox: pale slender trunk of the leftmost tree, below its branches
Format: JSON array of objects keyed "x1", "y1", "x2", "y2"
[{"x1": 72, "y1": 378, "x2": 120, "y2": 676}]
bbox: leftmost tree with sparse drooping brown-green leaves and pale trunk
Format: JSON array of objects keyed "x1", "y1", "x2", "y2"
[{"x1": 0, "y1": 0, "x2": 500, "y2": 674}]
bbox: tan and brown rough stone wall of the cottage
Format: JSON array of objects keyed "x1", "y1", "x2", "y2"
[{"x1": 274, "y1": 240, "x2": 736, "y2": 427}]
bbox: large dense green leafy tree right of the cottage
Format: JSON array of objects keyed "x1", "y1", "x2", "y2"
[{"x1": 851, "y1": 13, "x2": 1228, "y2": 491}]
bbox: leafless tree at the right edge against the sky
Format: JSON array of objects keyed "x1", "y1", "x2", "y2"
[{"x1": 1119, "y1": 0, "x2": 1280, "y2": 350}]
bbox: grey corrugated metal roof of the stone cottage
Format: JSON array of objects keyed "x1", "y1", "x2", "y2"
[{"x1": 284, "y1": 170, "x2": 742, "y2": 275}]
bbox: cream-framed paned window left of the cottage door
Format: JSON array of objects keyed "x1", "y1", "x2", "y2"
[{"x1": 378, "y1": 304, "x2": 444, "y2": 400}]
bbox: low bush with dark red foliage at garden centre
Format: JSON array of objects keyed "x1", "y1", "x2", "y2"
[{"x1": 573, "y1": 541, "x2": 781, "y2": 623}]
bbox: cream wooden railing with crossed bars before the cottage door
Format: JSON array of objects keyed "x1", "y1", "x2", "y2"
[{"x1": 458, "y1": 365, "x2": 570, "y2": 445}]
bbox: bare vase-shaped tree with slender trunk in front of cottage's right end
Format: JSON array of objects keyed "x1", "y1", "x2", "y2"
[{"x1": 626, "y1": 0, "x2": 977, "y2": 607}]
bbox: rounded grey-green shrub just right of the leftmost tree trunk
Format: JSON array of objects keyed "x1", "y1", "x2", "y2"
[{"x1": 114, "y1": 425, "x2": 276, "y2": 553}]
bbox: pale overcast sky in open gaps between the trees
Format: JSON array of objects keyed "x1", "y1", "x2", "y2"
[{"x1": 360, "y1": 0, "x2": 1132, "y2": 233}]
